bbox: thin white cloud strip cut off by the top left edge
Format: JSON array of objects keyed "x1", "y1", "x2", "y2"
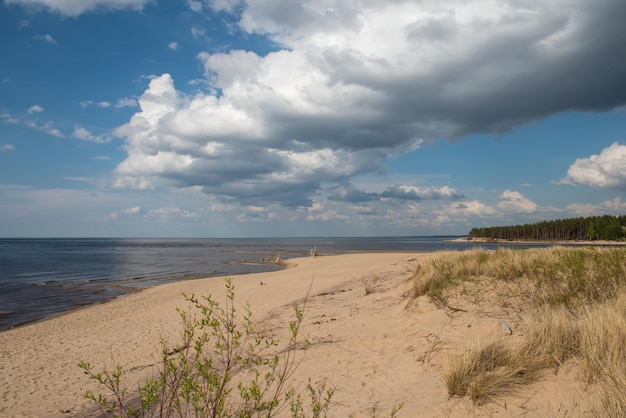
[{"x1": 6, "y1": 0, "x2": 151, "y2": 16}]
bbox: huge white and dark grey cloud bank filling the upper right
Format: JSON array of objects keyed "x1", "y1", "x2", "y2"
[{"x1": 115, "y1": 0, "x2": 626, "y2": 211}]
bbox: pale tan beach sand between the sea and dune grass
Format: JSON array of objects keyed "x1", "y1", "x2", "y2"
[{"x1": 0, "y1": 253, "x2": 590, "y2": 417}]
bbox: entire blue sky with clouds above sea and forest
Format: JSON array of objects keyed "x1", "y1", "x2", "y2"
[{"x1": 0, "y1": 0, "x2": 626, "y2": 237}]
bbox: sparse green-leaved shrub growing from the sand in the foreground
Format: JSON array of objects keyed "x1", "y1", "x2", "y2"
[{"x1": 79, "y1": 279, "x2": 334, "y2": 418}]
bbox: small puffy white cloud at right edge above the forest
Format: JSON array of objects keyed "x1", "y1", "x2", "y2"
[{"x1": 559, "y1": 142, "x2": 626, "y2": 190}]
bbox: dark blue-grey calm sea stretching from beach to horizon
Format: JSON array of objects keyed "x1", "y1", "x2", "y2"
[{"x1": 0, "y1": 236, "x2": 544, "y2": 331}]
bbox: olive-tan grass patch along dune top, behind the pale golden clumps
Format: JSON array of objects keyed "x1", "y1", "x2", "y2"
[{"x1": 413, "y1": 247, "x2": 626, "y2": 307}]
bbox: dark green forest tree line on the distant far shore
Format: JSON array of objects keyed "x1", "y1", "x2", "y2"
[{"x1": 469, "y1": 215, "x2": 626, "y2": 241}]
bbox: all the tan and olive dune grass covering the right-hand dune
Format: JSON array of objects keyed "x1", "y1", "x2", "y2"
[{"x1": 413, "y1": 247, "x2": 626, "y2": 416}]
